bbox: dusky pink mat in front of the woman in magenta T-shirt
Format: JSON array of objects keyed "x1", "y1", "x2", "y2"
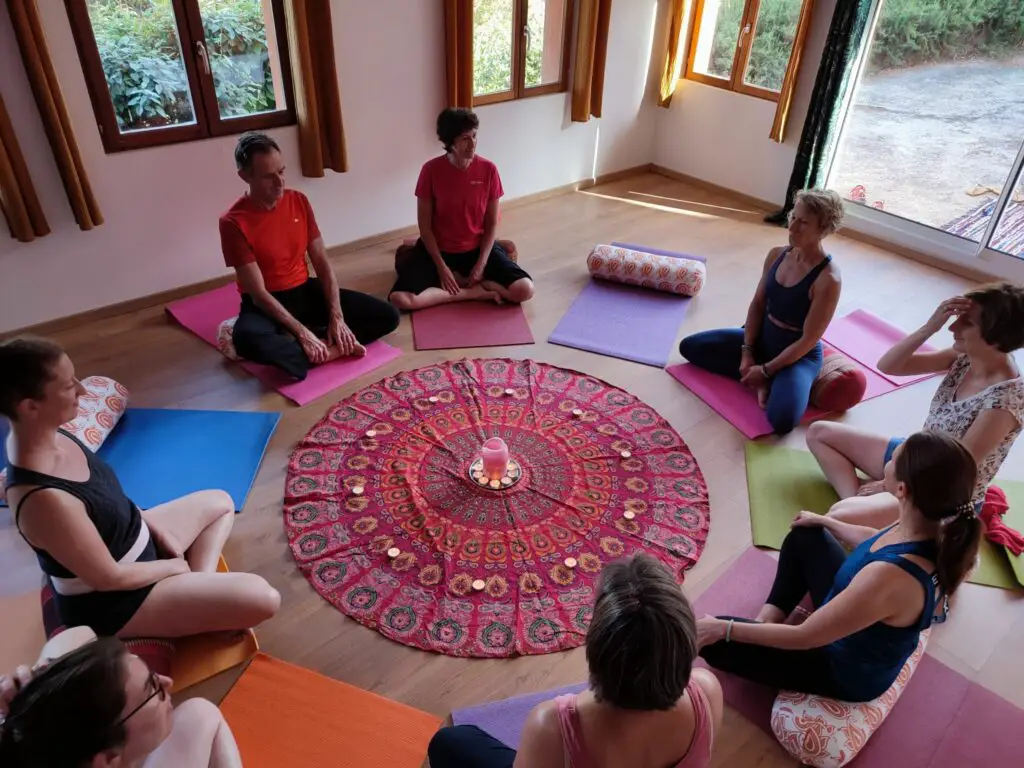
[{"x1": 413, "y1": 301, "x2": 534, "y2": 349}]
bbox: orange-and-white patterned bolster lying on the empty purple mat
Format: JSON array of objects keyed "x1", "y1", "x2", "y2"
[{"x1": 587, "y1": 246, "x2": 708, "y2": 296}]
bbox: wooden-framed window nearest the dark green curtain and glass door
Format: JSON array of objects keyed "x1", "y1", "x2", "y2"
[{"x1": 685, "y1": 0, "x2": 814, "y2": 101}]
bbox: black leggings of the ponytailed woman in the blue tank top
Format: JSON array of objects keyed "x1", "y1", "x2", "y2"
[{"x1": 700, "y1": 526, "x2": 863, "y2": 701}]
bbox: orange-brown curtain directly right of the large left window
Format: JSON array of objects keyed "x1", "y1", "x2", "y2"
[{"x1": 285, "y1": 0, "x2": 348, "y2": 177}]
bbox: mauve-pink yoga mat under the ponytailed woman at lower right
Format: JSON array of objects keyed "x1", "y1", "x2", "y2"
[{"x1": 693, "y1": 548, "x2": 1024, "y2": 768}]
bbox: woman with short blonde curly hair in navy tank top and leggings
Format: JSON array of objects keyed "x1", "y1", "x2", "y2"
[{"x1": 679, "y1": 189, "x2": 843, "y2": 434}]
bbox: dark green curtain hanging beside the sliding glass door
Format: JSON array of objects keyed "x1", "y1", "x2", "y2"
[{"x1": 765, "y1": 0, "x2": 874, "y2": 224}]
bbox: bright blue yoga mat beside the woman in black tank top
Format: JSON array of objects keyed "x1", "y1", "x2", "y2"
[{"x1": 98, "y1": 408, "x2": 281, "y2": 510}]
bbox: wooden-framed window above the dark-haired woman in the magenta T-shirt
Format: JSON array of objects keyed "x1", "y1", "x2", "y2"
[{"x1": 473, "y1": 0, "x2": 572, "y2": 106}]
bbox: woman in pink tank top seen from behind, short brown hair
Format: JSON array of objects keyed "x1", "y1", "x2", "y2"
[{"x1": 429, "y1": 554, "x2": 722, "y2": 768}]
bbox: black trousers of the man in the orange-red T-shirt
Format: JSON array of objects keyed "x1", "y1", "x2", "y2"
[{"x1": 234, "y1": 278, "x2": 399, "y2": 380}]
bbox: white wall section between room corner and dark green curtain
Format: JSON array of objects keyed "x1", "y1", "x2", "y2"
[{"x1": 653, "y1": 0, "x2": 836, "y2": 204}]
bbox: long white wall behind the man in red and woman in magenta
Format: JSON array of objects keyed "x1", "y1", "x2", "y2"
[{"x1": 0, "y1": 0, "x2": 658, "y2": 332}]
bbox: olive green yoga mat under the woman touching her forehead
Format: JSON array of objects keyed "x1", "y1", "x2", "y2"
[{"x1": 746, "y1": 442, "x2": 1024, "y2": 590}]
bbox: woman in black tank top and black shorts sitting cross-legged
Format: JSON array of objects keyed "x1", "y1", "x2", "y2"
[{"x1": 0, "y1": 339, "x2": 281, "y2": 637}]
